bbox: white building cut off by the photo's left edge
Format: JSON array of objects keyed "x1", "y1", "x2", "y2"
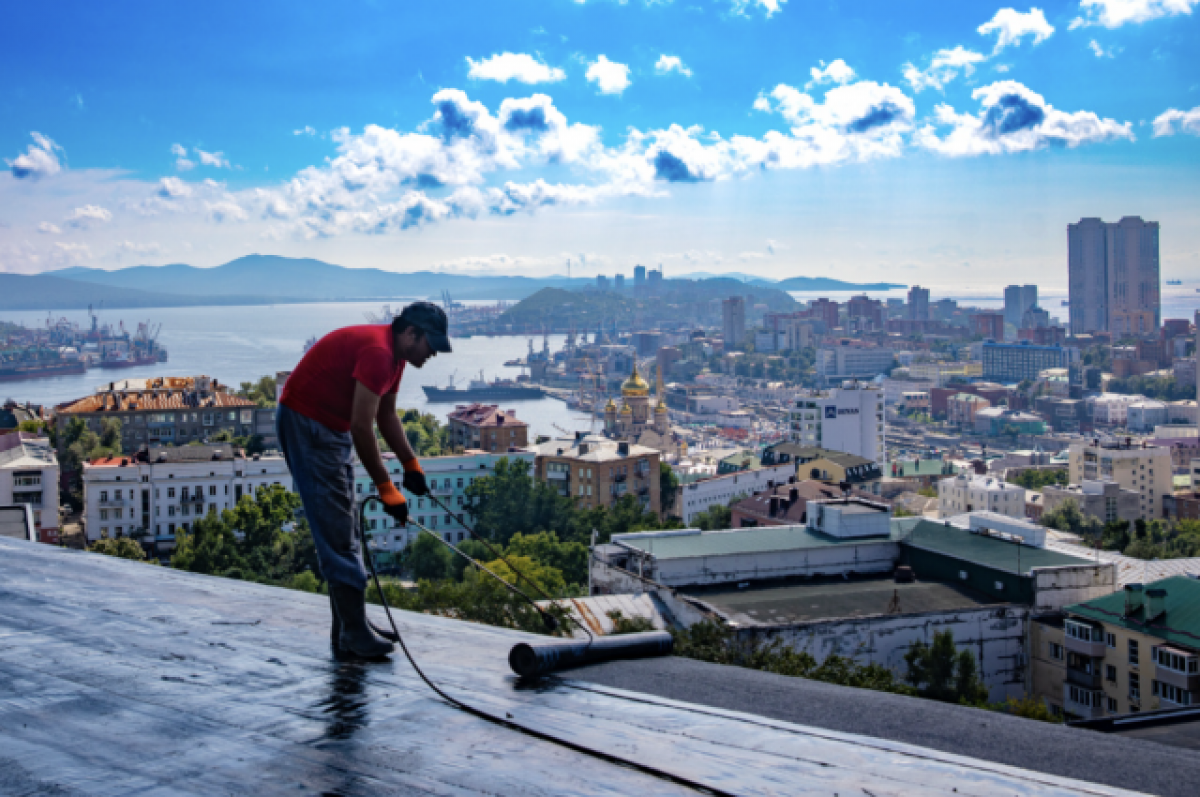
[{"x1": 0, "y1": 432, "x2": 59, "y2": 545}]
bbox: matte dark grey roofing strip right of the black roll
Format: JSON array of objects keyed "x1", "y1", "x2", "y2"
[{"x1": 569, "y1": 657, "x2": 1200, "y2": 797}]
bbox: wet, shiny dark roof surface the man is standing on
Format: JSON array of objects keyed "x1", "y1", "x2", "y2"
[{"x1": 0, "y1": 539, "x2": 1137, "y2": 797}]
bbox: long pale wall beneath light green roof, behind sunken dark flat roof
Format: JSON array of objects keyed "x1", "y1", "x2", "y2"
[{"x1": 653, "y1": 540, "x2": 900, "y2": 587}]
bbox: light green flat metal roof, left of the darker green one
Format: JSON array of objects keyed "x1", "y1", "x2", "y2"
[{"x1": 614, "y1": 526, "x2": 904, "y2": 562}]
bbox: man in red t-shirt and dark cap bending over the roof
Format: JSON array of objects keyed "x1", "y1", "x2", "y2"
[{"x1": 276, "y1": 301, "x2": 451, "y2": 658}]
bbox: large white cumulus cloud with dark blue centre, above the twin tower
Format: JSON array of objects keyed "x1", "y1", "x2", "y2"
[{"x1": 914, "y1": 80, "x2": 1134, "y2": 157}]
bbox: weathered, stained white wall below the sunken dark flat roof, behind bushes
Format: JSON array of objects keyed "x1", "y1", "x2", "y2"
[{"x1": 738, "y1": 605, "x2": 1030, "y2": 702}]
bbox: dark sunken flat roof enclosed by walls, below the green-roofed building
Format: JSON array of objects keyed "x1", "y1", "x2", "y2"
[{"x1": 684, "y1": 576, "x2": 1002, "y2": 624}]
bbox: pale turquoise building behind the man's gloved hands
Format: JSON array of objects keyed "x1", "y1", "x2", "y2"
[{"x1": 354, "y1": 449, "x2": 535, "y2": 555}]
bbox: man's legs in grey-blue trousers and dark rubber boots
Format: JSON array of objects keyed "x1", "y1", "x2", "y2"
[{"x1": 277, "y1": 406, "x2": 392, "y2": 658}]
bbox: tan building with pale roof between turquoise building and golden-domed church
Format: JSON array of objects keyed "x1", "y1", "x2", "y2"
[{"x1": 534, "y1": 435, "x2": 662, "y2": 515}]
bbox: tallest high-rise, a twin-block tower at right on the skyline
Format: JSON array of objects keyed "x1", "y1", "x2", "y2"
[{"x1": 1067, "y1": 216, "x2": 1162, "y2": 340}]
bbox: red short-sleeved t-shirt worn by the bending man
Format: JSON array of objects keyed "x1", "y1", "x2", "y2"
[{"x1": 280, "y1": 324, "x2": 404, "y2": 432}]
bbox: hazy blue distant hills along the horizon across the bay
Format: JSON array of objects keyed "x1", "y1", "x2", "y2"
[{"x1": 0, "y1": 254, "x2": 906, "y2": 310}]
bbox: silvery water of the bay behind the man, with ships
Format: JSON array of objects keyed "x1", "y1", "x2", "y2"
[{"x1": 0, "y1": 302, "x2": 590, "y2": 436}]
